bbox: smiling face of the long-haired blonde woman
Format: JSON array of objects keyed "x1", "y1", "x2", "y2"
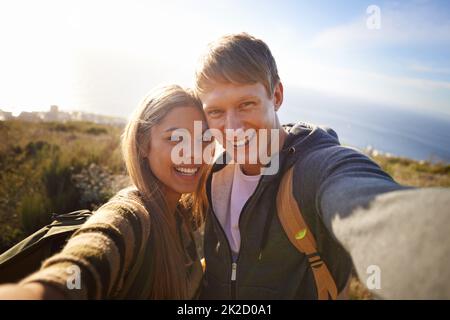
[{"x1": 148, "y1": 106, "x2": 207, "y2": 194}]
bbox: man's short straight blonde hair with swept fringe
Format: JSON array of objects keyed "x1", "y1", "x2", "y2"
[{"x1": 195, "y1": 33, "x2": 280, "y2": 97}]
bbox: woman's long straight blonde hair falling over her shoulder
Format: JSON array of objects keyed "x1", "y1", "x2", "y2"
[{"x1": 122, "y1": 85, "x2": 203, "y2": 299}]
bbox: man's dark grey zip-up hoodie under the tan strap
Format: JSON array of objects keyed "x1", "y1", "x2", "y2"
[{"x1": 202, "y1": 123, "x2": 450, "y2": 299}]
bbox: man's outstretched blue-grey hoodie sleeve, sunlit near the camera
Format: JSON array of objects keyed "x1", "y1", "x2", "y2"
[{"x1": 307, "y1": 146, "x2": 450, "y2": 299}]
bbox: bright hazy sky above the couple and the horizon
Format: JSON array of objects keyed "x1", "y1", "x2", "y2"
[{"x1": 0, "y1": 0, "x2": 450, "y2": 117}]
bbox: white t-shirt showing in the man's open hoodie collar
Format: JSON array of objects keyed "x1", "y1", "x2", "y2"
[{"x1": 227, "y1": 165, "x2": 261, "y2": 256}]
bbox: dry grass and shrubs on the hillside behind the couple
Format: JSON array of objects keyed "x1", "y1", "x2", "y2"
[{"x1": 0, "y1": 121, "x2": 450, "y2": 299}]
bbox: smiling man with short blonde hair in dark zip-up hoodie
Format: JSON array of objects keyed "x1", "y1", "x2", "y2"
[{"x1": 196, "y1": 33, "x2": 450, "y2": 299}]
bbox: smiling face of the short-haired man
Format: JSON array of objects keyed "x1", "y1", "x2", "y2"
[{"x1": 200, "y1": 83, "x2": 283, "y2": 169}]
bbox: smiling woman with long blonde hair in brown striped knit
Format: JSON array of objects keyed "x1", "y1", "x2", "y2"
[{"x1": 0, "y1": 85, "x2": 211, "y2": 299}]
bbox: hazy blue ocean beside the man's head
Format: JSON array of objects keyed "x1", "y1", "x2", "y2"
[{"x1": 279, "y1": 89, "x2": 450, "y2": 163}]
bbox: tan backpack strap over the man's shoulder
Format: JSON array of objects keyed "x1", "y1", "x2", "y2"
[{"x1": 277, "y1": 167, "x2": 338, "y2": 300}]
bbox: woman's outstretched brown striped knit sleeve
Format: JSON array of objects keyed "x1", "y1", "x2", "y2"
[{"x1": 21, "y1": 192, "x2": 150, "y2": 299}]
